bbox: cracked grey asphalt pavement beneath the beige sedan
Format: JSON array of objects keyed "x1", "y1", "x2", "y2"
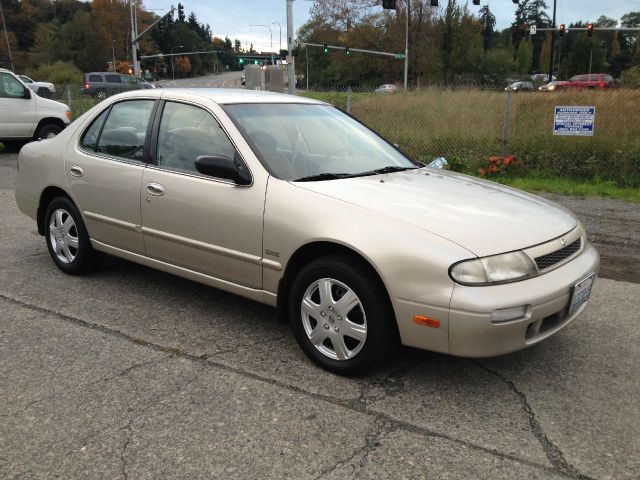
[{"x1": 0, "y1": 154, "x2": 640, "y2": 479}]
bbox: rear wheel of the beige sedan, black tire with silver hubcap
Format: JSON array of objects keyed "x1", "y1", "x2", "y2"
[{"x1": 44, "y1": 197, "x2": 104, "y2": 275}]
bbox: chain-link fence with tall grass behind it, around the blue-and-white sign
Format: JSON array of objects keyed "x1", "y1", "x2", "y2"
[{"x1": 300, "y1": 86, "x2": 640, "y2": 188}]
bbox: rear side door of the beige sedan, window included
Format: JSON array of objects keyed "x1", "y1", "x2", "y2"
[{"x1": 65, "y1": 99, "x2": 155, "y2": 255}]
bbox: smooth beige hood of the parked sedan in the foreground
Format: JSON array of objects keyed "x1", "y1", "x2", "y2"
[{"x1": 295, "y1": 168, "x2": 578, "y2": 257}]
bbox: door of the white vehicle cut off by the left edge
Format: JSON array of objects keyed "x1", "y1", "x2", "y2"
[{"x1": 0, "y1": 72, "x2": 36, "y2": 138}]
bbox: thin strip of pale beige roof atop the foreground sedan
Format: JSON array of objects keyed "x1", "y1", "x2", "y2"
[{"x1": 112, "y1": 88, "x2": 325, "y2": 105}]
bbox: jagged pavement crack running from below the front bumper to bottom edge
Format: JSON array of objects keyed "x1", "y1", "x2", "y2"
[{"x1": 469, "y1": 359, "x2": 591, "y2": 480}]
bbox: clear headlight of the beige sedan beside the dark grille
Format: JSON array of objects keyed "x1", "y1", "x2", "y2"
[{"x1": 449, "y1": 252, "x2": 537, "y2": 285}]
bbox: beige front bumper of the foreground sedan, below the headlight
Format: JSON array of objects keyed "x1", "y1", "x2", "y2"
[{"x1": 449, "y1": 241, "x2": 600, "y2": 357}]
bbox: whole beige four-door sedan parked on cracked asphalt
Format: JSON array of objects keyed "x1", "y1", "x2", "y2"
[{"x1": 15, "y1": 89, "x2": 599, "y2": 375}]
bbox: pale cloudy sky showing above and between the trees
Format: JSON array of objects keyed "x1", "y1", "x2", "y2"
[{"x1": 144, "y1": 0, "x2": 640, "y2": 51}]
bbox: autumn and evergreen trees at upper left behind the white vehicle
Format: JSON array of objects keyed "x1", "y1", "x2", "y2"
[{"x1": 0, "y1": 0, "x2": 242, "y2": 83}]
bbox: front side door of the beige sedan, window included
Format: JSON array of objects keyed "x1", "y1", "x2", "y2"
[{"x1": 141, "y1": 101, "x2": 267, "y2": 288}]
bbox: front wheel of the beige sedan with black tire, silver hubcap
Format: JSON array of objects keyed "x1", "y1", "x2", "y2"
[{"x1": 289, "y1": 256, "x2": 398, "y2": 376}]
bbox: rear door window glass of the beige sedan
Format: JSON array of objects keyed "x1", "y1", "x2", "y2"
[{"x1": 97, "y1": 100, "x2": 154, "y2": 163}]
